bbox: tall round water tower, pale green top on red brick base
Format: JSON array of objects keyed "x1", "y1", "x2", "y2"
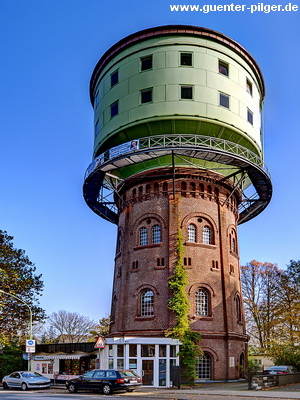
[{"x1": 83, "y1": 25, "x2": 272, "y2": 386}]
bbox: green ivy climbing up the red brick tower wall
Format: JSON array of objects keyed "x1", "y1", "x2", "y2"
[{"x1": 168, "y1": 223, "x2": 202, "y2": 383}]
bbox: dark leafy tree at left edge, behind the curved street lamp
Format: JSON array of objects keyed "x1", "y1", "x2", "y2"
[{"x1": 0, "y1": 231, "x2": 45, "y2": 344}]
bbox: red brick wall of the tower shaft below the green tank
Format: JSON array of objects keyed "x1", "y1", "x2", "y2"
[{"x1": 111, "y1": 168, "x2": 246, "y2": 379}]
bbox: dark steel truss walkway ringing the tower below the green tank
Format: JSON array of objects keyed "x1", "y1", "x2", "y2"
[{"x1": 83, "y1": 135, "x2": 272, "y2": 224}]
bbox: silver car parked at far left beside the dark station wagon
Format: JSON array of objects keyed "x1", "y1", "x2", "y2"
[{"x1": 2, "y1": 371, "x2": 50, "y2": 390}]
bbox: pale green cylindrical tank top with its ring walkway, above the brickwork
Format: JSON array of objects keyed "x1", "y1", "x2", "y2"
[{"x1": 83, "y1": 25, "x2": 272, "y2": 223}]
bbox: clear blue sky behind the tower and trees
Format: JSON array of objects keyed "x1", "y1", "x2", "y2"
[{"x1": 0, "y1": 0, "x2": 300, "y2": 320}]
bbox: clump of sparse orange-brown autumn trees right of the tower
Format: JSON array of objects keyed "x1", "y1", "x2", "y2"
[{"x1": 241, "y1": 260, "x2": 300, "y2": 367}]
